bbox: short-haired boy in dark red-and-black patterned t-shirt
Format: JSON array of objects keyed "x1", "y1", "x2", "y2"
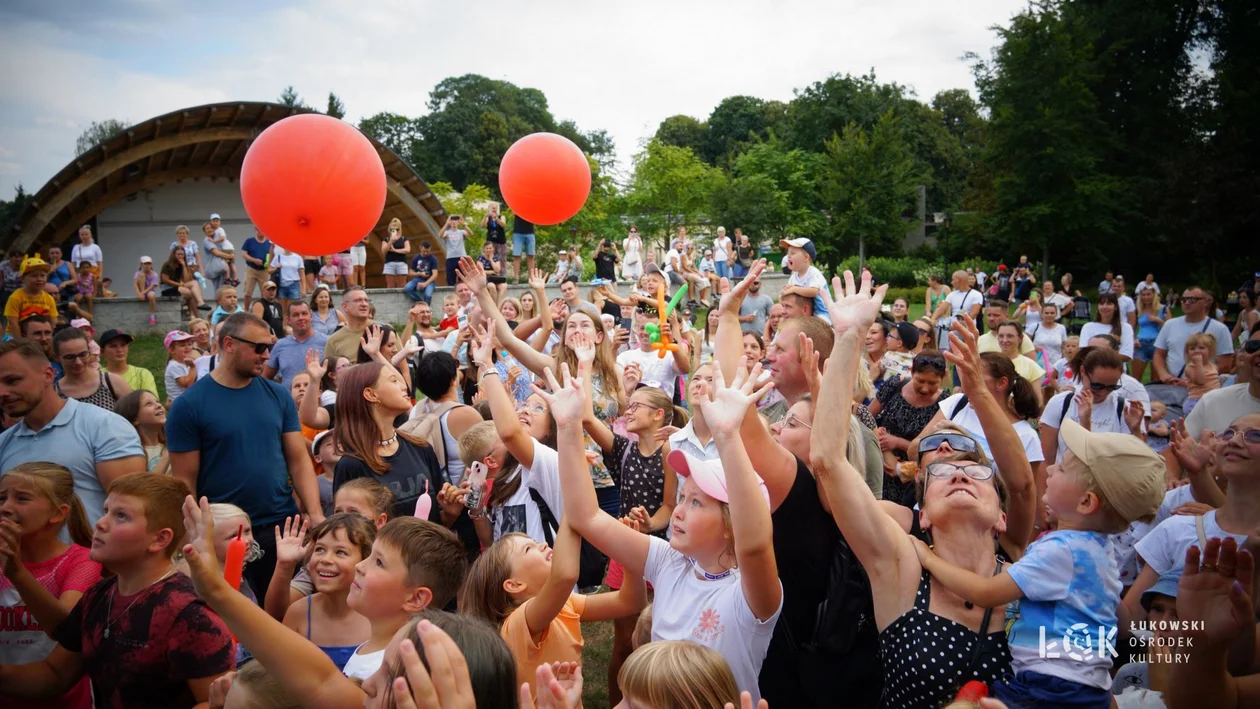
[{"x1": 0, "y1": 472, "x2": 234, "y2": 709}]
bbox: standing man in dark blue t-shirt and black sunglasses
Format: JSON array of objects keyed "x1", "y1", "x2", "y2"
[{"x1": 166, "y1": 312, "x2": 324, "y2": 598}]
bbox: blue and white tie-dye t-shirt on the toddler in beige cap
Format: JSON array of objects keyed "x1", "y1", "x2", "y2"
[{"x1": 1007, "y1": 530, "x2": 1120, "y2": 689}]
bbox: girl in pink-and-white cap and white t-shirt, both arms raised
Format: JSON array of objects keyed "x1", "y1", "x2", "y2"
[{"x1": 539, "y1": 366, "x2": 782, "y2": 699}]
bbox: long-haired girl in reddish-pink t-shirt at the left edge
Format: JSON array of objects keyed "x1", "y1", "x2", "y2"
[{"x1": 0, "y1": 462, "x2": 101, "y2": 709}]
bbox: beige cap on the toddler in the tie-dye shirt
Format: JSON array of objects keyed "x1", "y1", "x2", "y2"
[{"x1": 1058, "y1": 418, "x2": 1166, "y2": 521}]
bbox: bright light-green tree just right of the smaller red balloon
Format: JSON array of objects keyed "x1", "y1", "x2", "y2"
[{"x1": 626, "y1": 140, "x2": 721, "y2": 248}]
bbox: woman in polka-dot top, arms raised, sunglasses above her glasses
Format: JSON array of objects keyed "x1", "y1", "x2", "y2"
[{"x1": 811, "y1": 273, "x2": 1037, "y2": 708}]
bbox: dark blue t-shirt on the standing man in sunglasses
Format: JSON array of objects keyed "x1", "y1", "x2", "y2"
[{"x1": 166, "y1": 377, "x2": 301, "y2": 525}]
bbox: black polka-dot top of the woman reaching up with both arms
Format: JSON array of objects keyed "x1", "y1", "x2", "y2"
[{"x1": 879, "y1": 569, "x2": 1011, "y2": 709}]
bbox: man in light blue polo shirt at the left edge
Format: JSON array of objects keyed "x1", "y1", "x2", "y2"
[{"x1": 0, "y1": 339, "x2": 145, "y2": 524}]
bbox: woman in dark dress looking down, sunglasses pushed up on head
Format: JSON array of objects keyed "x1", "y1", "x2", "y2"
[{"x1": 869, "y1": 354, "x2": 945, "y2": 508}]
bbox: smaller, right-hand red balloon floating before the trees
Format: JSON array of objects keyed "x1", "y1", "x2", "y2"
[{"x1": 499, "y1": 133, "x2": 591, "y2": 224}]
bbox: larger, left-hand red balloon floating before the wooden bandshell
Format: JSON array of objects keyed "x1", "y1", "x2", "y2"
[{"x1": 241, "y1": 113, "x2": 386, "y2": 256}]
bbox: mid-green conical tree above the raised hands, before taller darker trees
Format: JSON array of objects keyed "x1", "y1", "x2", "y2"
[{"x1": 815, "y1": 111, "x2": 922, "y2": 263}]
